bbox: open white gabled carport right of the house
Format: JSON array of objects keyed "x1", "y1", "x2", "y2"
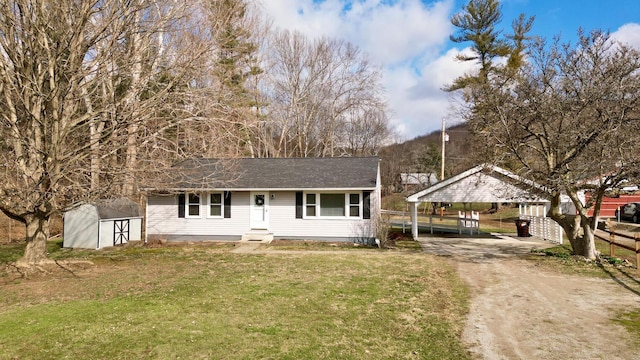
[{"x1": 407, "y1": 164, "x2": 549, "y2": 240}]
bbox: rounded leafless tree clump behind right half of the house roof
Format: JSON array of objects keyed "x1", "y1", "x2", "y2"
[{"x1": 263, "y1": 31, "x2": 389, "y2": 157}]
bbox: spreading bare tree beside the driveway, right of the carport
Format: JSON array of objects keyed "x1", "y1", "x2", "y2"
[{"x1": 467, "y1": 31, "x2": 640, "y2": 259}]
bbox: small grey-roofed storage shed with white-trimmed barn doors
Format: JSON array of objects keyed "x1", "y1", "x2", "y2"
[{"x1": 62, "y1": 198, "x2": 142, "y2": 249}]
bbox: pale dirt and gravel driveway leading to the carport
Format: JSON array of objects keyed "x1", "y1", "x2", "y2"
[{"x1": 421, "y1": 237, "x2": 640, "y2": 359}]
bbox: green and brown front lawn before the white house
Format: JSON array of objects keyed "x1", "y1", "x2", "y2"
[{"x1": 0, "y1": 240, "x2": 469, "y2": 359}]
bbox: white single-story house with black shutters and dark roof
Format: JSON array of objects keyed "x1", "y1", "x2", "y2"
[{"x1": 143, "y1": 157, "x2": 380, "y2": 242}]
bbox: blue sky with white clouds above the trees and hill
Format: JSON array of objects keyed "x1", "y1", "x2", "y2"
[{"x1": 262, "y1": 0, "x2": 640, "y2": 141}]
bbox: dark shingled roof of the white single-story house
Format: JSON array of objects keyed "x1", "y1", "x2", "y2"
[{"x1": 152, "y1": 157, "x2": 379, "y2": 190}]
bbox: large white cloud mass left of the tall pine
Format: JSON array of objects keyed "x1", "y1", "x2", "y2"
[{"x1": 263, "y1": 0, "x2": 461, "y2": 138}]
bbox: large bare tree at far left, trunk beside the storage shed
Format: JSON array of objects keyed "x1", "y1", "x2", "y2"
[{"x1": 0, "y1": 0, "x2": 205, "y2": 265}]
